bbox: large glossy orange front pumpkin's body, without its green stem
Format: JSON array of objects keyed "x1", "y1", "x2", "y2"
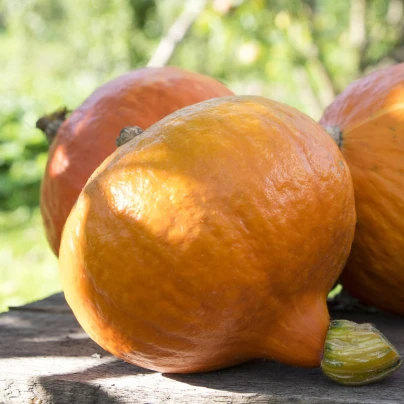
[{"x1": 59, "y1": 96, "x2": 355, "y2": 373}]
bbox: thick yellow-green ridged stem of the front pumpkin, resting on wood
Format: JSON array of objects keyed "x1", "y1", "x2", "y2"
[{"x1": 321, "y1": 320, "x2": 402, "y2": 386}]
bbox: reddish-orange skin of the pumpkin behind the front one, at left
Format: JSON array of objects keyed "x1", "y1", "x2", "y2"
[{"x1": 40, "y1": 67, "x2": 233, "y2": 255}]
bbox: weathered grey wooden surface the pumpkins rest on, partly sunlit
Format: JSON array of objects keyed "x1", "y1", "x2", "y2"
[{"x1": 0, "y1": 294, "x2": 404, "y2": 404}]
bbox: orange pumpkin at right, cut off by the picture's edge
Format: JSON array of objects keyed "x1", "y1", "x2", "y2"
[{"x1": 320, "y1": 64, "x2": 404, "y2": 315}]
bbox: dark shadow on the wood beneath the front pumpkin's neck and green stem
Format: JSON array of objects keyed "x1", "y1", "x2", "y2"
[{"x1": 163, "y1": 360, "x2": 402, "y2": 403}]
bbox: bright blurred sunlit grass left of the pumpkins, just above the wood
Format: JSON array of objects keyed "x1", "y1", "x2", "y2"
[{"x1": 0, "y1": 208, "x2": 61, "y2": 312}]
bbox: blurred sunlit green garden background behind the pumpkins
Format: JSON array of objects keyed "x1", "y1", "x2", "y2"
[{"x1": 0, "y1": 0, "x2": 404, "y2": 311}]
